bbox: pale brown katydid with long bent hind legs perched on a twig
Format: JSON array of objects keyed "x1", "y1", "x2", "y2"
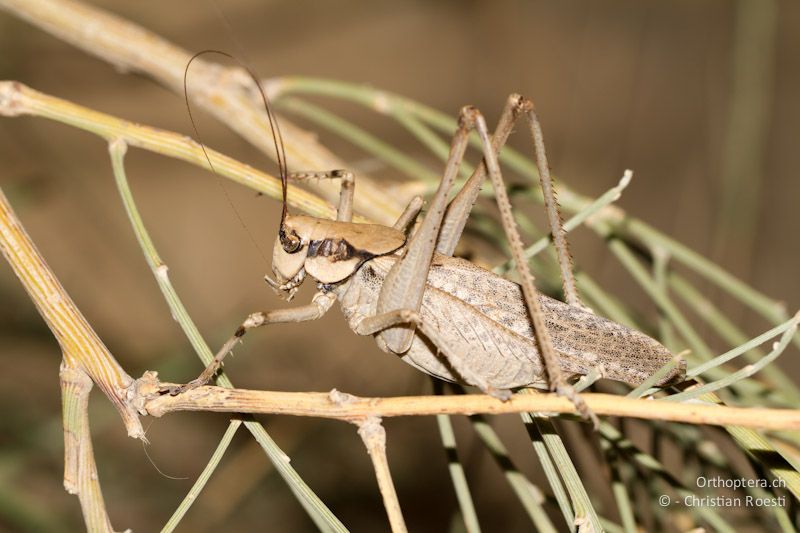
[{"x1": 170, "y1": 54, "x2": 685, "y2": 417}]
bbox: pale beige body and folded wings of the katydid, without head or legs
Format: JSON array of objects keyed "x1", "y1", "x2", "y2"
[{"x1": 332, "y1": 254, "x2": 682, "y2": 390}]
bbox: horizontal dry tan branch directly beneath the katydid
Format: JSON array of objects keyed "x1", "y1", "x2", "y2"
[{"x1": 142, "y1": 375, "x2": 800, "y2": 429}]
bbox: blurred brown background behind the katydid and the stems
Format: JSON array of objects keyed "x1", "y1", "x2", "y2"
[{"x1": 0, "y1": 0, "x2": 800, "y2": 531}]
